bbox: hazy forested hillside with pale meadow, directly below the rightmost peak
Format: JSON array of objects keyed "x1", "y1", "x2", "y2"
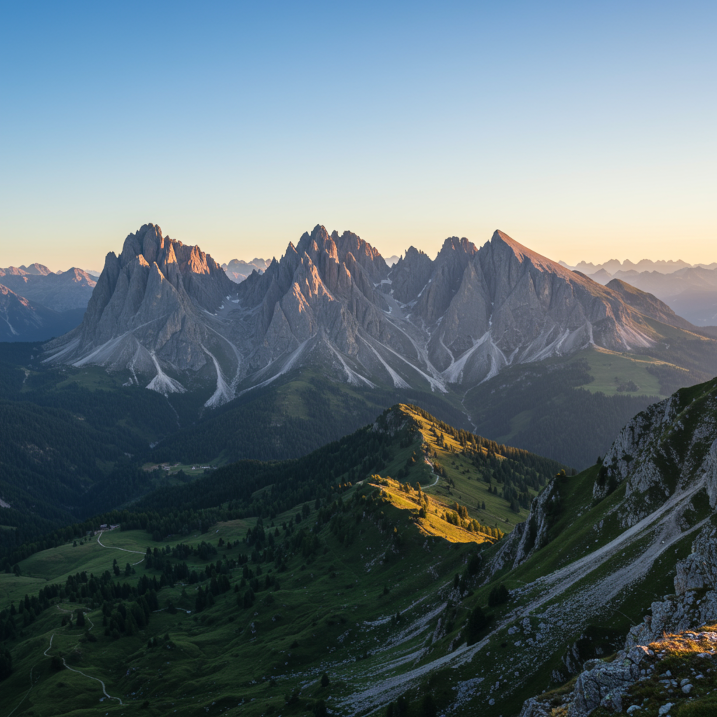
[{"x1": 462, "y1": 319, "x2": 717, "y2": 469}]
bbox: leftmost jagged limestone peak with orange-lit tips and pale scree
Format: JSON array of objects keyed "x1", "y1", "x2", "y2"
[{"x1": 47, "y1": 224, "x2": 241, "y2": 402}]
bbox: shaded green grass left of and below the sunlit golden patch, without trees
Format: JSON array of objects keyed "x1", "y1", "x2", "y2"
[{"x1": 0, "y1": 496, "x2": 478, "y2": 715}]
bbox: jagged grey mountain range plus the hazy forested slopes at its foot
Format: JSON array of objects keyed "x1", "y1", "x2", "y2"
[{"x1": 37, "y1": 224, "x2": 717, "y2": 467}]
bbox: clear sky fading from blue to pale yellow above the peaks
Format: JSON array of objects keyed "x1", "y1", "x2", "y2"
[{"x1": 0, "y1": 0, "x2": 717, "y2": 270}]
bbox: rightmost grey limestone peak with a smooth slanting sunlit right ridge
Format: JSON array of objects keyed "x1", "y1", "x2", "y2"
[{"x1": 416, "y1": 231, "x2": 652, "y2": 383}]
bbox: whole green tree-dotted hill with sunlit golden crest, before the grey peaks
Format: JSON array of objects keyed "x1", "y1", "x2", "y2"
[{"x1": 0, "y1": 406, "x2": 560, "y2": 715}]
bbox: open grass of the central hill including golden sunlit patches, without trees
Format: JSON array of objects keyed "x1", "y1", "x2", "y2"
[{"x1": 0, "y1": 408, "x2": 564, "y2": 715}]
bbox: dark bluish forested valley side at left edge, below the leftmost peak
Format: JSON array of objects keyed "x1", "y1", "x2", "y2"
[{"x1": 0, "y1": 344, "x2": 182, "y2": 536}]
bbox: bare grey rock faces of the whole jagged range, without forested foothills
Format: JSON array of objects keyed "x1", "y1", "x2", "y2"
[{"x1": 48, "y1": 224, "x2": 712, "y2": 406}]
